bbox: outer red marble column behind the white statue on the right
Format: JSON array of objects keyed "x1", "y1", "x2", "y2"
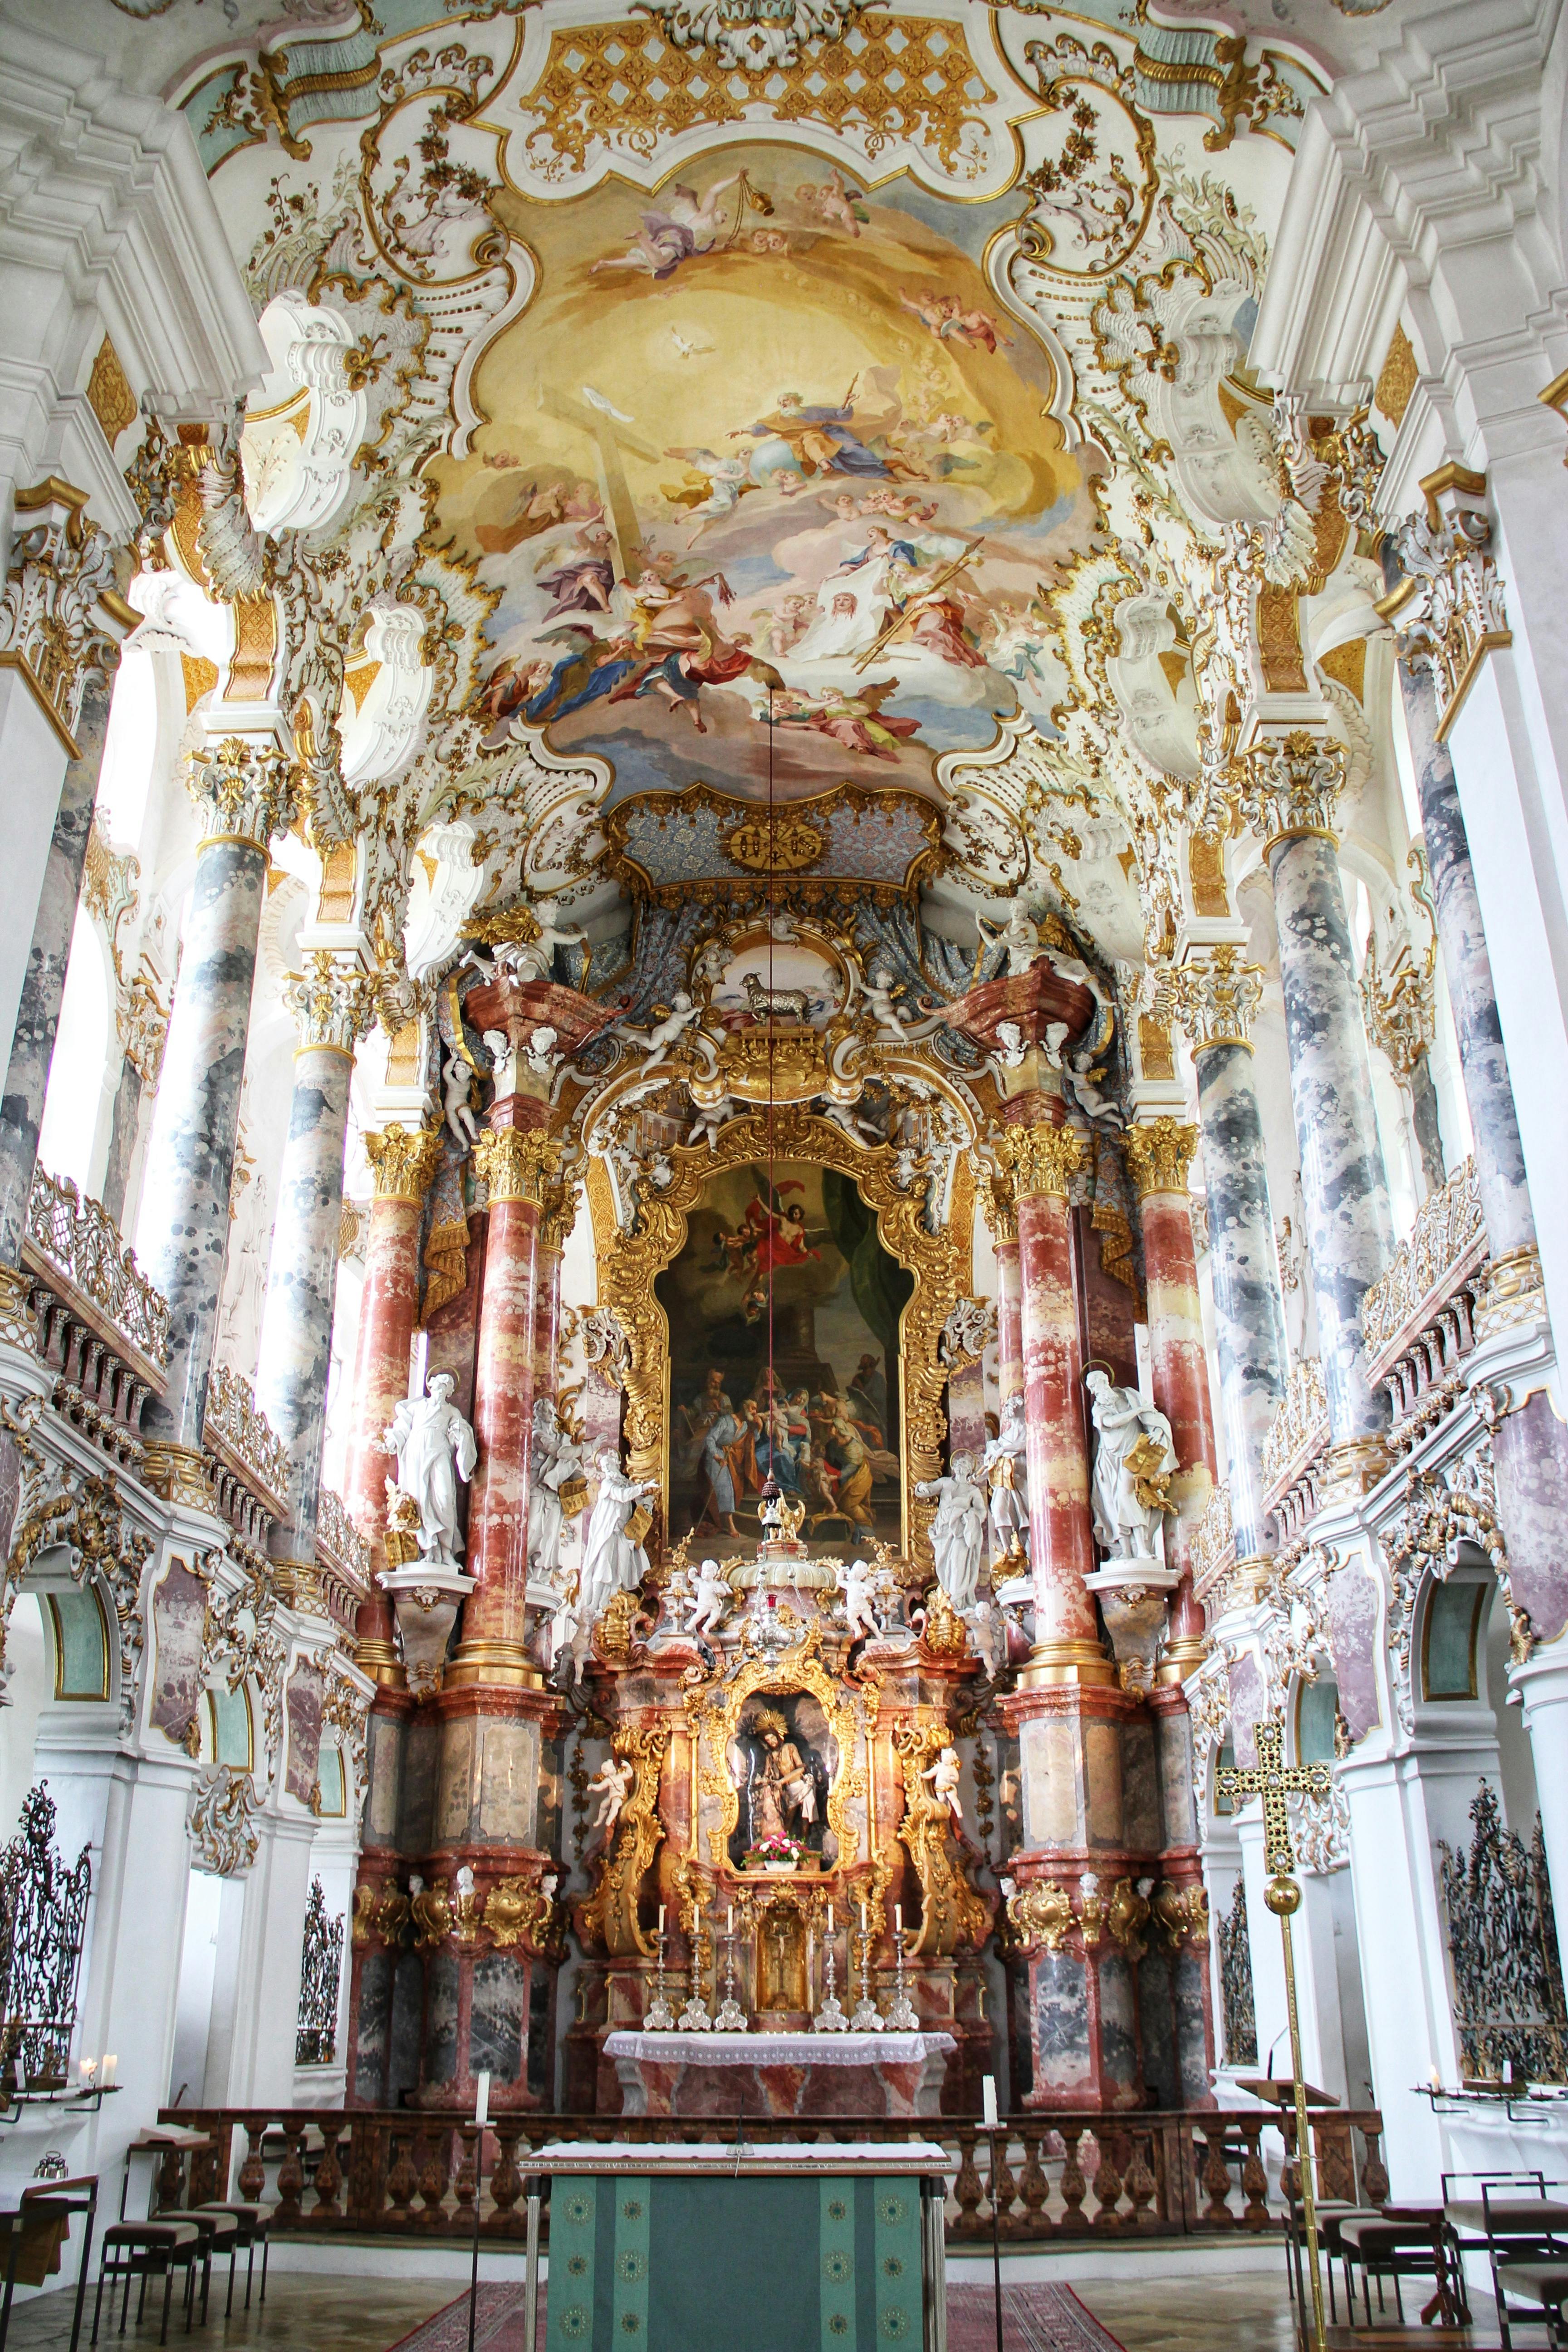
[{"x1": 1126, "y1": 1120, "x2": 1218, "y2": 1679}]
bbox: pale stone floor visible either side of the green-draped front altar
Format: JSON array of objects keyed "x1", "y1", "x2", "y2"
[{"x1": 10, "y1": 2265, "x2": 1523, "y2": 2352}]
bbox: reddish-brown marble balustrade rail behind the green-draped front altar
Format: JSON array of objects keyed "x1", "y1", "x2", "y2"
[{"x1": 157, "y1": 2107, "x2": 1389, "y2": 2244}]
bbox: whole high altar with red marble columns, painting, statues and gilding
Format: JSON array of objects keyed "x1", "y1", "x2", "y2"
[{"x1": 355, "y1": 894, "x2": 1210, "y2": 2117}]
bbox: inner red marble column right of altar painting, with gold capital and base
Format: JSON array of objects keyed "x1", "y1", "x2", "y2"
[{"x1": 1001, "y1": 1098, "x2": 1114, "y2": 1682}]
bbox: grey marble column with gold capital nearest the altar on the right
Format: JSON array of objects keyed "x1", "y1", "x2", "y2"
[{"x1": 1171, "y1": 943, "x2": 1288, "y2": 1562}]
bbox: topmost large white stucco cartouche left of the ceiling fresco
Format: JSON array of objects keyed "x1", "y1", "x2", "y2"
[{"x1": 240, "y1": 287, "x2": 367, "y2": 532}]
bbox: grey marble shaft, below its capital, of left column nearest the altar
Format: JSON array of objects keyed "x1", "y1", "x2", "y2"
[{"x1": 256, "y1": 1044, "x2": 353, "y2": 1559}]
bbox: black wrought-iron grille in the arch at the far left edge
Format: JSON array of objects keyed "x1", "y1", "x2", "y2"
[{"x1": 0, "y1": 1783, "x2": 92, "y2": 2084}]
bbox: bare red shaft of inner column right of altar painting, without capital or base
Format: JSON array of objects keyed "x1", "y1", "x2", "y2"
[{"x1": 1018, "y1": 1192, "x2": 1098, "y2": 1649}]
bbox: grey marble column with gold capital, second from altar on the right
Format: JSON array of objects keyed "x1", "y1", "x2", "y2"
[{"x1": 1236, "y1": 729, "x2": 1394, "y2": 1472}]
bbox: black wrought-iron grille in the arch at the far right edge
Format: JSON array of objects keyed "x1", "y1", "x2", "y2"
[{"x1": 1436, "y1": 1780, "x2": 1568, "y2": 2082}]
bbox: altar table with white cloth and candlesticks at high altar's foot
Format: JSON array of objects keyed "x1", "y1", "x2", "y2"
[{"x1": 604, "y1": 2030, "x2": 957, "y2": 2117}]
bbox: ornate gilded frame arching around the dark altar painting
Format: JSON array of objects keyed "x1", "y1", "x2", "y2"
[{"x1": 585, "y1": 1091, "x2": 973, "y2": 1567}]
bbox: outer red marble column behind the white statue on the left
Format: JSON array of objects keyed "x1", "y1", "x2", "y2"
[{"x1": 343, "y1": 1122, "x2": 442, "y2": 1689}]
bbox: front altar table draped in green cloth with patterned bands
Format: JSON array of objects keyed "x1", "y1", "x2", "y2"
[{"x1": 539, "y1": 2140, "x2": 947, "y2": 2352}]
